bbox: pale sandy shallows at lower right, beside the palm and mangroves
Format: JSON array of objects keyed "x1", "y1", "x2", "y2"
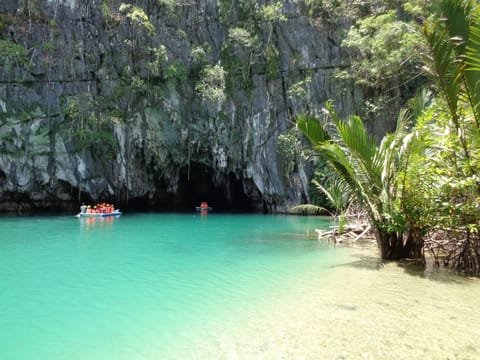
[{"x1": 179, "y1": 249, "x2": 480, "y2": 359}]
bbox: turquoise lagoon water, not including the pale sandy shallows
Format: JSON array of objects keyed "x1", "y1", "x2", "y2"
[{"x1": 0, "y1": 214, "x2": 334, "y2": 359}]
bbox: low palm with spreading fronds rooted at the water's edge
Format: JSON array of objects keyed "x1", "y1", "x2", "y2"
[{"x1": 297, "y1": 102, "x2": 424, "y2": 262}]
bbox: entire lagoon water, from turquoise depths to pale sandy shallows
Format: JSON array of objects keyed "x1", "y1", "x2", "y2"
[{"x1": 0, "y1": 214, "x2": 480, "y2": 360}]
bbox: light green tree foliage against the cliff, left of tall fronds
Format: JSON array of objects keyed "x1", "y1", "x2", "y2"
[{"x1": 335, "y1": 0, "x2": 428, "y2": 123}]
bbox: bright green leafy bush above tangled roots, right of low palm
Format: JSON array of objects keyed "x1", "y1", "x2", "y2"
[{"x1": 405, "y1": 99, "x2": 480, "y2": 275}]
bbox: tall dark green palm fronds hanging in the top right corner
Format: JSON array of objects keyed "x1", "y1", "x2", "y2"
[{"x1": 424, "y1": 0, "x2": 480, "y2": 167}]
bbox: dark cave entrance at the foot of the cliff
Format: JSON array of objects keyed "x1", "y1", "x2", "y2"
[{"x1": 173, "y1": 163, "x2": 254, "y2": 212}]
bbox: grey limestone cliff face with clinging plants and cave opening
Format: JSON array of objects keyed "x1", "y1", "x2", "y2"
[{"x1": 0, "y1": 0, "x2": 361, "y2": 212}]
